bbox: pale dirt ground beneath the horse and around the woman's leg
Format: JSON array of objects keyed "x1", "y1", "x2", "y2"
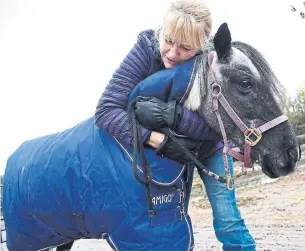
[{"x1": 67, "y1": 165, "x2": 305, "y2": 251}]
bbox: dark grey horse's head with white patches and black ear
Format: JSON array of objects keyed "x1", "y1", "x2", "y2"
[{"x1": 191, "y1": 24, "x2": 299, "y2": 178}]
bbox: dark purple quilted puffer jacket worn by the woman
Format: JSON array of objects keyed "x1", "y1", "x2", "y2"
[{"x1": 95, "y1": 30, "x2": 217, "y2": 146}]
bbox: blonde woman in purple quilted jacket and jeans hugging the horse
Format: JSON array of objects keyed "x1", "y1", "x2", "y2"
[{"x1": 95, "y1": 0, "x2": 255, "y2": 251}]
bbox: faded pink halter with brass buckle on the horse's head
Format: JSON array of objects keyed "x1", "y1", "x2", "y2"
[{"x1": 208, "y1": 51, "x2": 288, "y2": 190}]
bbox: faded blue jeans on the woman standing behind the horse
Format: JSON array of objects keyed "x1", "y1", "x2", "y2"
[{"x1": 203, "y1": 153, "x2": 255, "y2": 251}]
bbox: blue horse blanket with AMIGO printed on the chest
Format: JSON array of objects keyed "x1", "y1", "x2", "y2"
[{"x1": 3, "y1": 58, "x2": 201, "y2": 251}]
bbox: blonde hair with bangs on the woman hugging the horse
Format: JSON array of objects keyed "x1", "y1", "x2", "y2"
[{"x1": 158, "y1": 0, "x2": 212, "y2": 49}]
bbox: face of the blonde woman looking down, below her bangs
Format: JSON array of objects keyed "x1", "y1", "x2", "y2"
[{"x1": 160, "y1": 36, "x2": 200, "y2": 68}]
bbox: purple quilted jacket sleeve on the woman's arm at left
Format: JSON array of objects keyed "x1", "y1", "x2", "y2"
[{"x1": 95, "y1": 31, "x2": 153, "y2": 146}]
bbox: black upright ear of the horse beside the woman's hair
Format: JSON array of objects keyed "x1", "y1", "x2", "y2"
[{"x1": 213, "y1": 23, "x2": 232, "y2": 62}]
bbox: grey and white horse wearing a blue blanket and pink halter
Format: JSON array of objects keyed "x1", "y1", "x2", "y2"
[{"x1": 3, "y1": 23, "x2": 299, "y2": 251}]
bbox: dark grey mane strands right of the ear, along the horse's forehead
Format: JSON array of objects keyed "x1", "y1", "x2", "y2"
[{"x1": 232, "y1": 41, "x2": 286, "y2": 108}]
